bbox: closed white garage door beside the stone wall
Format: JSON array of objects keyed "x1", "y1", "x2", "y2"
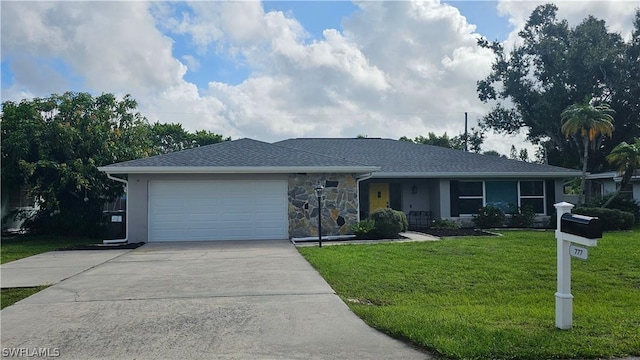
[{"x1": 149, "y1": 180, "x2": 288, "y2": 242}]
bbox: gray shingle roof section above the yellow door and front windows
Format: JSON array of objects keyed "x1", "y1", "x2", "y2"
[{"x1": 275, "y1": 138, "x2": 579, "y2": 176}]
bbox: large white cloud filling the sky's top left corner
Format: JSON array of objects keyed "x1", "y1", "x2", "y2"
[{"x1": 2, "y1": 2, "x2": 186, "y2": 96}]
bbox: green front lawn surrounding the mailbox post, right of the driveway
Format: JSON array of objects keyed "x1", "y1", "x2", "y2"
[{"x1": 299, "y1": 230, "x2": 640, "y2": 359}]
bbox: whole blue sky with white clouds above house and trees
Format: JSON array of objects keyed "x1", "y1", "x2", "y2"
[{"x1": 0, "y1": 0, "x2": 638, "y2": 153}]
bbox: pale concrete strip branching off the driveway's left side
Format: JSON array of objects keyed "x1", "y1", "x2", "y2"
[{"x1": 0, "y1": 250, "x2": 130, "y2": 288}]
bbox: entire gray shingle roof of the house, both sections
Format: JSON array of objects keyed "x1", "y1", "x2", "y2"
[{"x1": 101, "y1": 138, "x2": 580, "y2": 177}]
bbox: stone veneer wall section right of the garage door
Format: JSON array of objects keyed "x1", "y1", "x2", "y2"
[{"x1": 289, "y1": 174, "x2": 358, "y2": 238}]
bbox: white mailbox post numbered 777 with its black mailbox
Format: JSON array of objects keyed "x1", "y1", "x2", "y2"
[{"x1": 554, "y1": 202, "x2": 602, "y2": 330}]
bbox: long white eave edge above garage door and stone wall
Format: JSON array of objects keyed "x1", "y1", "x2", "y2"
[{"x1": 98, "y1": 166, "x2": 380, "y2": 174}]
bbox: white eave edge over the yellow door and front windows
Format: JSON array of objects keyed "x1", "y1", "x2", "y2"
[{"x1": 372, "y1": 171, "x2": 582, "y2": 179}]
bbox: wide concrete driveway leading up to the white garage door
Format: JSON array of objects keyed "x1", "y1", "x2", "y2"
[{"x1": 0, "y1": 241, "x2": 430, "y2": 359}]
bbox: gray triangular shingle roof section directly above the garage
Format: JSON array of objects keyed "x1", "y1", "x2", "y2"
[{"x1": 104, "y1": 139, "x2": 368, "y2": 169}]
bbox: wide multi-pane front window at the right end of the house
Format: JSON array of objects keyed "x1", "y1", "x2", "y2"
[{"x1": 452, "y1": 180, "x2": 546, "y2": 215}]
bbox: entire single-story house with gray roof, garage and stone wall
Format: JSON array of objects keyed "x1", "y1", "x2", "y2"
[{"x1": 100, "y1": 138, "x2": 581, "y2": 242}]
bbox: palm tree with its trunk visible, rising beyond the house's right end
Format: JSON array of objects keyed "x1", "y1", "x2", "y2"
[{"x1": 560, "y1": 99, "x2": 615, "y2": 201}]
